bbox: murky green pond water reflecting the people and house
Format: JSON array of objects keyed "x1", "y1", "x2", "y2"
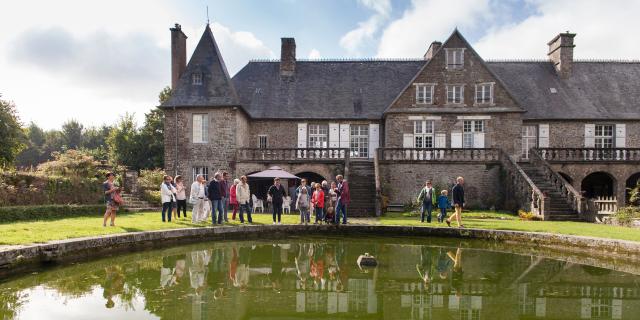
[{"x1": 0, "y1": 237, "x2": 640, "y2": 320}]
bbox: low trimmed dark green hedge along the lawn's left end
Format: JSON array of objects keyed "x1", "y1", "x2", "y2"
[{"x1": 0, "y1": 204, "x2": 131, "y2": 223}]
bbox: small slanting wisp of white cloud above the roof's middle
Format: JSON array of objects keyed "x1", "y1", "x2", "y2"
[{"x1": 340, "y1": 0, "x2": 391, "y2": 56}]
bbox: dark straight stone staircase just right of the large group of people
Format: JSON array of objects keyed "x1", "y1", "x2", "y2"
[{"x1": 347, "y1": 159, "x2": 376, "y2": 217}]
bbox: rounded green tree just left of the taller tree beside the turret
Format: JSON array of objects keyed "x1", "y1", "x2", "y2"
[{"x1": 107, "y1": 113, "x2": 140, "y2": 169}]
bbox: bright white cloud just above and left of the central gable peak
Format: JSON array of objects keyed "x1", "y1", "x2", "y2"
[{"x1": 377, "y1": 0, "x2": 492, "y2": 58}]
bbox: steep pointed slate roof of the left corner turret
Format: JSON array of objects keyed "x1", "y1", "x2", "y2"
[{"x1": 162, "y1": 24, "x2": 240, "y2": 107}]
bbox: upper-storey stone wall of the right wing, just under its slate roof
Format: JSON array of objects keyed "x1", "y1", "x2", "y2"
[{"x1": 523, "y1": 120, "x2": 640, "y2": 148}]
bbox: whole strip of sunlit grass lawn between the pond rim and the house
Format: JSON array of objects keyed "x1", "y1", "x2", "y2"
[{"x1": 0, "y1": 211, "x2": 640, "y2": 245}]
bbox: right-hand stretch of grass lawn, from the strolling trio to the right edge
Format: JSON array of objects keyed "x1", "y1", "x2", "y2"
[{"x1": 380, "y1": 212, "x2": 640, "y2": 241}]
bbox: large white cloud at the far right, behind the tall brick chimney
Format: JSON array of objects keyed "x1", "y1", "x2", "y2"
[{"x1": 475, "y1": 0, "x2": 640, "y2": 59}]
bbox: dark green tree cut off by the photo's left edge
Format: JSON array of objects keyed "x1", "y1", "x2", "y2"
[{"x1": 0, "y1": 96, "x2": 26, "y2": 168}]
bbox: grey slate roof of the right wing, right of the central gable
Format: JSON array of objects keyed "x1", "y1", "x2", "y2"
[{"x1": 487, "y1": 61, "x2": 640, "y2": 120}]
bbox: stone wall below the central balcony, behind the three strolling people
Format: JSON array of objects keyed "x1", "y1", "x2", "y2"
[{"x1": 380, "y1": 163, "x2": 503, "y2": 209}]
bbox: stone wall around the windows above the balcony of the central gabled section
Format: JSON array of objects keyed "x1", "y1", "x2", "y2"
[{"x1": 384, "y1": 113, "x2": 522, "y2": 155}]
